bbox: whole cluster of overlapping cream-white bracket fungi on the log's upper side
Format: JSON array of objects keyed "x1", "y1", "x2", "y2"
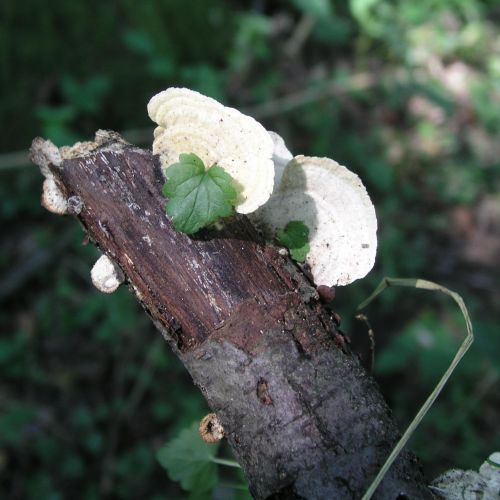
[{"x1": 148, "y1": 88, "x2": 377, "y2": 286}]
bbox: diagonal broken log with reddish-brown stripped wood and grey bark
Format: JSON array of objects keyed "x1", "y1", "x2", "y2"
[{"x1": 34, "y1": 137, "x2": 431, "y2": 500}]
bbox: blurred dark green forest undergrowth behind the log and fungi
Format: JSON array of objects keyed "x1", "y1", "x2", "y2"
[{"x1": 0, "y1": 0, "x2": 500, "y2": 500}]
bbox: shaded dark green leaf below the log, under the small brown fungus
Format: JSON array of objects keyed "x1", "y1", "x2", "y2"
[{"x1": 157, "y1": 422, "x2": 218, "y2": 495}]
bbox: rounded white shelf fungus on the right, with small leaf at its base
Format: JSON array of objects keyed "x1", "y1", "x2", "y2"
[{"x1": 252, "y1": 156, "x2": 377, "y2": 286}]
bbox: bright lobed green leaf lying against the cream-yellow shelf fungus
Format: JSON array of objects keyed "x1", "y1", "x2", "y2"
[{"x1": 163, "y1": 153, "x2": 237, "y2": 234}]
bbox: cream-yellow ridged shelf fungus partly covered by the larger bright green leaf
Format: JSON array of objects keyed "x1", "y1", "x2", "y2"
[{"x1": 148, "y1": 88, "x2": 274, "y2": 214}]
